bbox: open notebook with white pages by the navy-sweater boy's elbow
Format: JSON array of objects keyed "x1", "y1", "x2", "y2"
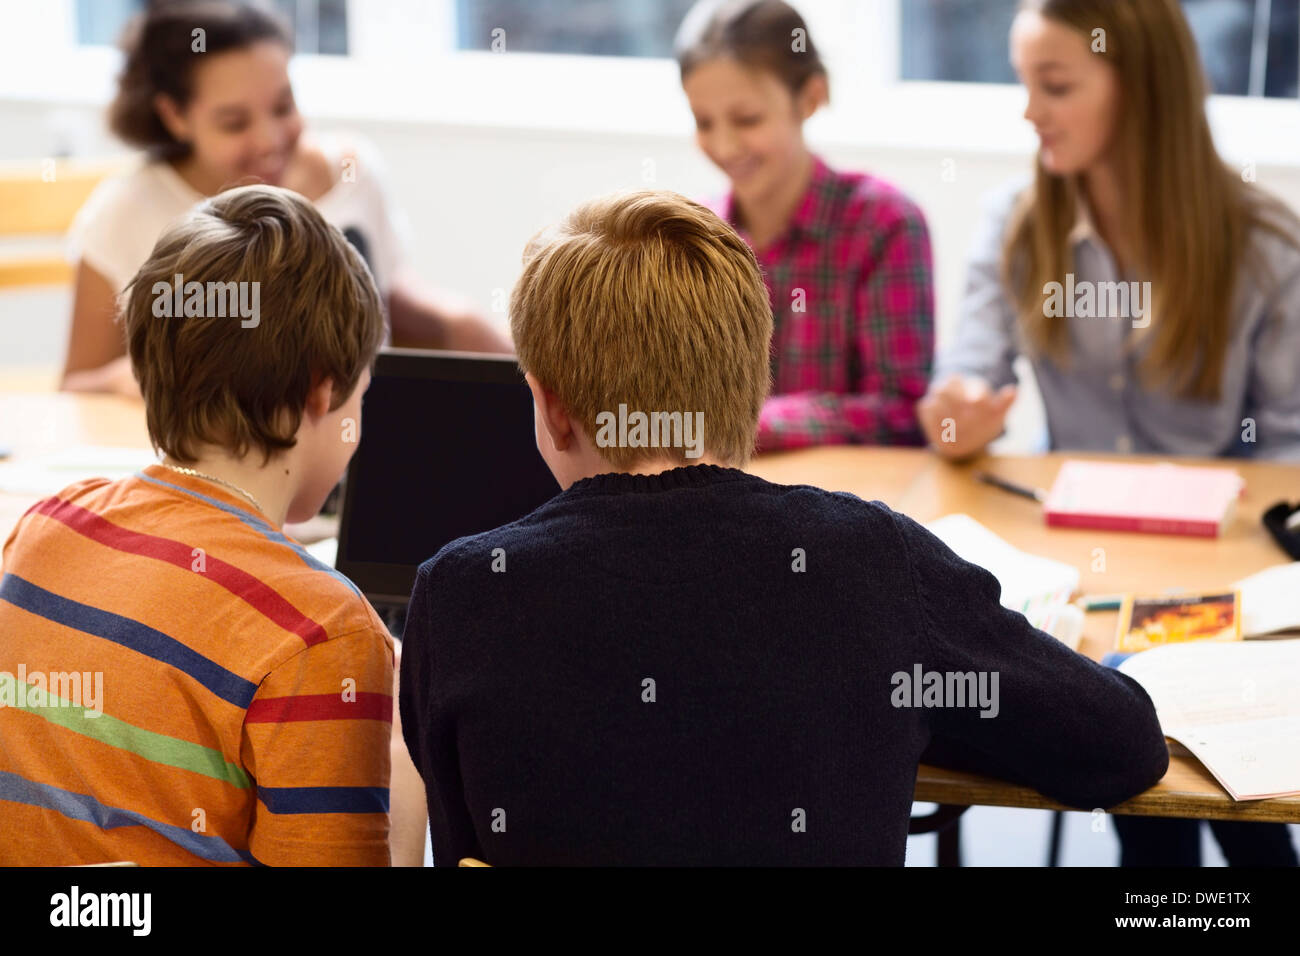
[{"x1": 1119, "y1": 640, "x2": 1300, "y2": 800}]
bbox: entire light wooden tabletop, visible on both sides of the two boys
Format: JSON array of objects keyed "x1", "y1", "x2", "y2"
[{"x1": 0, "y1": 390, "x2": 1300, "y2": 822}]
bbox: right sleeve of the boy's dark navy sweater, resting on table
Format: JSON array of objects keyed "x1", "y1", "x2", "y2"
[{"x1": 894, "y1": 514, "x2": 1169, "y2": 809}]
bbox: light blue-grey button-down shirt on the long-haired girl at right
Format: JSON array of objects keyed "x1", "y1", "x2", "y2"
[{"x1": 935, "y1": 189, "x2": 1300, "y2": 460}]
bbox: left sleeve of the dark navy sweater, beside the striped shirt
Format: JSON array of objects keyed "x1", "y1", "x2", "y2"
[{"x1": 398, "y1": 563, "x2": 484, "y2": 866}]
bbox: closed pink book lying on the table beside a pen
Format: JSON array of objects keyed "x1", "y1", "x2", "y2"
[{"x1": 1043, "y1": 460, "x2": 1245, "y2": 537}]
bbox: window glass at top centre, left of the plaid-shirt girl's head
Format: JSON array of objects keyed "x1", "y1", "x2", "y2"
[{"x1": 456, "y1": 0, "x2": 694, "y2": 57}]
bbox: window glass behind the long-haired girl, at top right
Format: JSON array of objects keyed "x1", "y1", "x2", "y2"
[{"x1": 902, "y1": 0, "x2": 1300, "y2": 99}]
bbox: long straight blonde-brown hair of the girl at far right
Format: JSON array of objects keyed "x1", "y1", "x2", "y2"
[{"x1": 1002, "y1": 0, "x2": 1296, "y2": 401}]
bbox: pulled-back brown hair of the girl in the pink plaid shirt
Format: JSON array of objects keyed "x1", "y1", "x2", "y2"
[{"x1": 673, "y1": 0, "x2": 829, "y2": 95}]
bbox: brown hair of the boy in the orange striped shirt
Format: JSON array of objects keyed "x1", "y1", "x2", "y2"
[{"x1": 124, "y1": 186, "x2": 384, "y2": 462}]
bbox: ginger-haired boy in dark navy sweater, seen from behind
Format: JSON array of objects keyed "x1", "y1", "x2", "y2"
[{"x1": 399, "y1": 193, "x2": 1169, "y2": 865}]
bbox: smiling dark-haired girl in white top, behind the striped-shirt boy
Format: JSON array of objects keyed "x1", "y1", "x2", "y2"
[{"x1": 62, "y1": 0, "x2": 512, "y2": 394}]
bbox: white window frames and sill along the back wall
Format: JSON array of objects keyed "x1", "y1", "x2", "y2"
[{"x1": 0, "y1": 0, "x2": 1300, "y2": 169}]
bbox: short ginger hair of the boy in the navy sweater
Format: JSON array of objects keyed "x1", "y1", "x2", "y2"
[{"x1": 510, "y1": 191, "x2": 772, "y2": 468}]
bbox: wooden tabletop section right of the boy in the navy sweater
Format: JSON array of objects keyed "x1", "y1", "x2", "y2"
[{"x1": 750, "y1": 447, "x2": 1300, "y2": 823}]
